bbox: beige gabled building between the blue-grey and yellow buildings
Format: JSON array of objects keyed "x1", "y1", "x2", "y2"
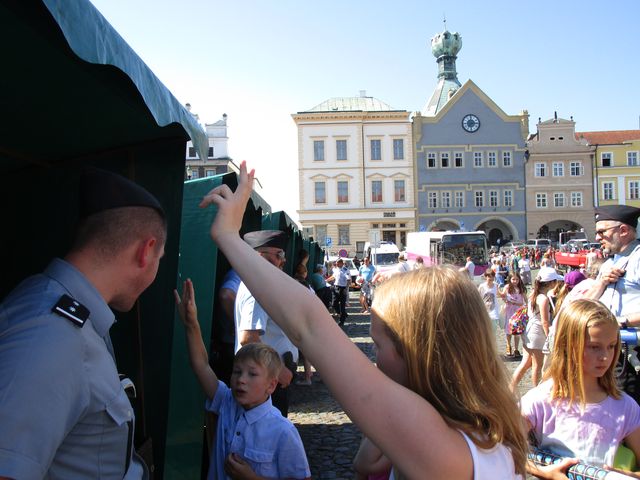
[{"x1": 525, "y1": 115, "x2": 595, "y2": 241}]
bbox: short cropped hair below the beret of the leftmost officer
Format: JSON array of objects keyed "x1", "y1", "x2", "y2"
[{"x1": 72, "y1": 207, "x2": 167, "y2": 258}]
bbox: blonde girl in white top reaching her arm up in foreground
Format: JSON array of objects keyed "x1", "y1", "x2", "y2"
[{"x1": 200, "y1": 162, "x2": 527, "y2": 480}]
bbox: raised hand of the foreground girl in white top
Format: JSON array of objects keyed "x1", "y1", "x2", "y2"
[{"x1": 199, "y1": 160, "x2": 254, "y2": 243}]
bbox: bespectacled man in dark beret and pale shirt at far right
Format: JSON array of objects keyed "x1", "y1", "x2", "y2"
[{"x1": 588, "y1": 205, "x2": 640, "y2": 401}]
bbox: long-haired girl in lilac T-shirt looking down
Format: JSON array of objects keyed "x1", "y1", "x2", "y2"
[{"x1": 521, "y1": 299, "x2": 640, "y2": 478}]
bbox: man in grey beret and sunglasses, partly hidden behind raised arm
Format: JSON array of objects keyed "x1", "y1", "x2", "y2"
[{"x1": 234, "y1": 230, "x2": 298, "y2": 417}]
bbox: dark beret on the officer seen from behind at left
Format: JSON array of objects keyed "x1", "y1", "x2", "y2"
[{"x1": 80, "y1": 168, "x2": 165, "y2": 218}]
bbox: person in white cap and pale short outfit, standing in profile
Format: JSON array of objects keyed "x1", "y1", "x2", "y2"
[{"x1": 511, "y1": 267, "x2": 562, "y2": 392}]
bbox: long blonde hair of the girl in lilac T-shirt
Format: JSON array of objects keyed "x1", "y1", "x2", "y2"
[{"x1": 545, "y1": 299, "x2": 620, "y2": 407}]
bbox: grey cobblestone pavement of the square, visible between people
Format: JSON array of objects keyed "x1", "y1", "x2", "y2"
[{"x1": 289, "y1": 286, "x2": 531, "y2": 479}]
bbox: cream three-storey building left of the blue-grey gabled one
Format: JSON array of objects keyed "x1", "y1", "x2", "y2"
[{"x1": 292, "y1": 92, "x2": 415, "y2": 256}]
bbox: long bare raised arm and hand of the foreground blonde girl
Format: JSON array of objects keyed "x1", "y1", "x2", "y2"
[{"x1": 200, "y1": 162, "x2": 473, "y2": 480}]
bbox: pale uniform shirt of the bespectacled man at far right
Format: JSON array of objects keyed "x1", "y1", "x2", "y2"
[{"x1": 600, "y1": 240, "x2": 640, "y2": 316}]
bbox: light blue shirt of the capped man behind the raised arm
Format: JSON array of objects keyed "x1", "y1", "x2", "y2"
[{"x1": 234, "y1": 282, "x2": 298, "y2": 362}]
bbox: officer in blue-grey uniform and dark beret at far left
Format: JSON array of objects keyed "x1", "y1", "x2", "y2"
[{"x1": 0, "y1": 169, "x2": 166, "y2": 479}]
